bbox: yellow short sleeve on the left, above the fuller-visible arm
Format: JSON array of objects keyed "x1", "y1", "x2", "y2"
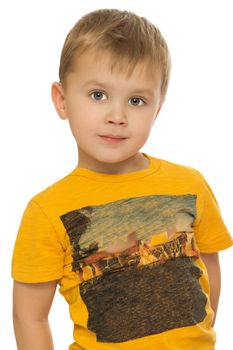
[{"x1": 12, "y1": 200, "x2": 64, "y2": 283}]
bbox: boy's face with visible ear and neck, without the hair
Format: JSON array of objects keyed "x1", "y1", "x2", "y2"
[{"x1": 52, "y1": 52, "x2": 162, "y2": 173}]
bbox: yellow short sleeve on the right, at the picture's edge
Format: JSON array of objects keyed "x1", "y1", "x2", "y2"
[{"x1": 195, "y1": 172, "x2": 233, "y2": 253}]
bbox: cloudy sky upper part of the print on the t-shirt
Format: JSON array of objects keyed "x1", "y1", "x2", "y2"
[{"x1": 61, "y1": 195, "x2": 196, "y2": 280}]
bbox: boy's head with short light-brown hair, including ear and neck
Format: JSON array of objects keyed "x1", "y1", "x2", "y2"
[{"x1": 52, "y1": 9, "x2": 171, "y2": 172}]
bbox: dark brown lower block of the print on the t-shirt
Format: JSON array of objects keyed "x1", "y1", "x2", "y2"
[{"x1": 80, "y1": 258, "x2": 207, "y2": 342}]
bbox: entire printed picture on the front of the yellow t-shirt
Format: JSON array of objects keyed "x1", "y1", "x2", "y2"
[{"x1": 60, "y1": 194, "x2": 207, "y2": 342}]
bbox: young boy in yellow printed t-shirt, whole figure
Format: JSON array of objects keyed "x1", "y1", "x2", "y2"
[{"x1": 12, "y1": 10, "x2": 232, "y2": 350}]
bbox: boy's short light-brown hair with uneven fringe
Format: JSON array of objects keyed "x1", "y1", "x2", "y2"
[{"x1": 59, "y1": 9, "x2": 171, "y2": 97}]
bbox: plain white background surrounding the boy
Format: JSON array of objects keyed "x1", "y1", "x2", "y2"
[{"x1": 0, "y1": 0, "x2": 233, "y2": 350}]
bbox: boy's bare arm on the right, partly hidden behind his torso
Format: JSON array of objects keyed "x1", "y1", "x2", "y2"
[{"x1": 201, "y1": 252, "x2": 221, "y2": 327}]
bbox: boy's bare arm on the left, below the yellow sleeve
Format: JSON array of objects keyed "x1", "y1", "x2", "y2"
[{"x1": 13, "y1": 281, "x2": 57, "y2": 350}]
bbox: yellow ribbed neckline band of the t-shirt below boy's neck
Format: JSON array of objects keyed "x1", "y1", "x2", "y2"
[{"x1": 70, "y1": 152, "x2": 161, "y2": 182}]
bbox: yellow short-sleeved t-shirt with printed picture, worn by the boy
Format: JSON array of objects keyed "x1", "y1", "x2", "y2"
[{"x1": 12, "y1": 153, "x2": 233, "y2": 350}]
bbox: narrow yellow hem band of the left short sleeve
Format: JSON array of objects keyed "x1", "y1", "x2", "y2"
[{"x1": 11, "y1": 270, "x2": 63, "y2": 283}]
